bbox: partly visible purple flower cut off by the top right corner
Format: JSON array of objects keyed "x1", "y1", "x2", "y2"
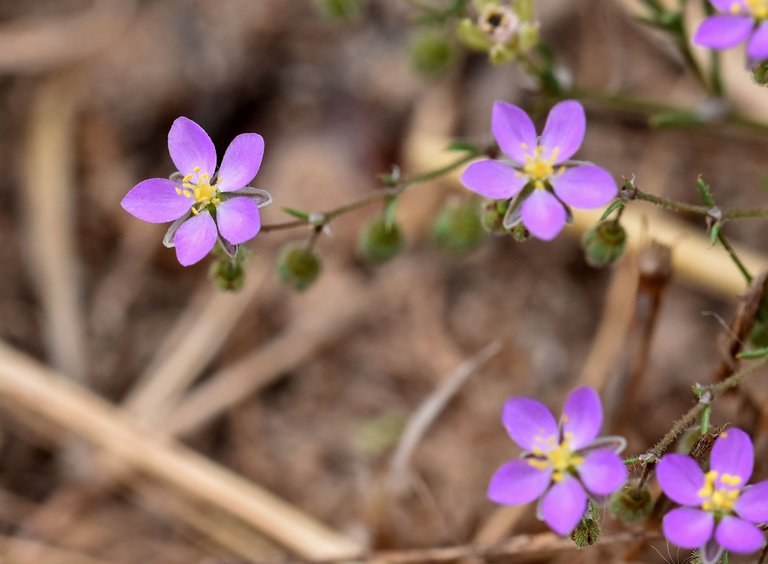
[{"x1": 693, "y1": 0, "x2": 768, "y2": 61}]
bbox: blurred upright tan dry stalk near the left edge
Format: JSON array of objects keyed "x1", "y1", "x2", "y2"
[{"x1": 21, "y1": 74, "x2": 86, "y2": 380}]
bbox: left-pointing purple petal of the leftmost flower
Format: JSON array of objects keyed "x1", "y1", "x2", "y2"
[{"x1": 120, "y1": 178, "x2": 194, "y2": 223}]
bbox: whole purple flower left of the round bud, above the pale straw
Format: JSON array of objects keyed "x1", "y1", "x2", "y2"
[{"x1": 461, "y1": 100, "x2": 618, "y2": 240}]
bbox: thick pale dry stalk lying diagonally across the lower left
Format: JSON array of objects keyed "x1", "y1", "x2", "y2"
[{"x1": 0, "y1": 345, "x2": 359, "y2": 558}]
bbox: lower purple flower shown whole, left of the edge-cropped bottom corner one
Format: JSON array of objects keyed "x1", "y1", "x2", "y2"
[{"x1": 488, "y1": 387, "x2": 627, "y2": 535}]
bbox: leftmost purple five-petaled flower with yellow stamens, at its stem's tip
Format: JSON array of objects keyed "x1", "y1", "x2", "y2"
[{"x1": 121, "y1": 117, "x2": 270, "y2": 266}]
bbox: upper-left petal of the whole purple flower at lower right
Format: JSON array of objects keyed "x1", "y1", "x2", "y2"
[{"x1": 501, "y1": 397, "x2": 559, "y2": 451}]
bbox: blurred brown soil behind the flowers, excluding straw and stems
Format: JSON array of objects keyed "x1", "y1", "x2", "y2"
[{"x1": 0, "y1": 0, "x2": 768, "y2": 564}]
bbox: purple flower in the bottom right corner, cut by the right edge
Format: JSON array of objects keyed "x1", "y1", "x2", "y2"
[{"x1": 656, "y1": 428, "x2": 768, "y2": 564}]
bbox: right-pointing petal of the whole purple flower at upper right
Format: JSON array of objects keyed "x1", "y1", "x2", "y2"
[{"x1": 549, "y1": 165, "x2": 619, "y2": 210}]
